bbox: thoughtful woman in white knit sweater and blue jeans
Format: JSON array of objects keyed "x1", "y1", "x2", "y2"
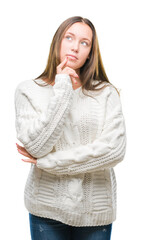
[{"x1": 15, "y1": 17, "x2": 126, "y2": 240}]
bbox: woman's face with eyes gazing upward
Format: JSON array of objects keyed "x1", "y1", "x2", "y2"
[{"x1": 60, "y1": 22, "x2": 92, "y2": 72}]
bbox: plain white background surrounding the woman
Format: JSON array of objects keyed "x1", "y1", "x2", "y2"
[{"x1": 0, "y1": 0, "x2": 141, "y2": 240}]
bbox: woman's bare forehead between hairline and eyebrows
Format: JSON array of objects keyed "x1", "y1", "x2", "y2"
[{"x1": 66, "y1": 22, "x2": 92, "y2": 39}]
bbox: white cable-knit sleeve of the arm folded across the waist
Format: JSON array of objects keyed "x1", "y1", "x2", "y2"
[{"x1": 37, "y1": 87, "x2": 126, "y2": 175}]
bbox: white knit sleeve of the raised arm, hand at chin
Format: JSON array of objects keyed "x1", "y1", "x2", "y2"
[{"x1": 15, "y1": 74, "x2": 73, "y2": 158}]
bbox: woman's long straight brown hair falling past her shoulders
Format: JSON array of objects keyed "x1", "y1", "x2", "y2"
[{"x1": 35, "y1": 16, "x2": 119, "y2": 93}]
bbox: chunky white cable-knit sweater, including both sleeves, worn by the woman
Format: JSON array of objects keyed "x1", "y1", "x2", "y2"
[{"x1": 14, "y1": 74, "x2": 126, "y2": 226}]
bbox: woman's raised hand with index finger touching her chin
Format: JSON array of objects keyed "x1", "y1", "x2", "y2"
[{"x1": 57, "y1": 57, "x2": 79, "y2": 84}]
